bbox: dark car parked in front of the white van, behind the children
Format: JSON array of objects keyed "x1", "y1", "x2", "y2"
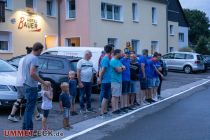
[{"x1": 39, "y1": 55, "x2": 98, "y2": 100}]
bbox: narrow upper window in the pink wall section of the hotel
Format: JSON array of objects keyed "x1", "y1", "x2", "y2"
[{"x1": 66, "y1": 0, "x2": 76, "y2": 19}]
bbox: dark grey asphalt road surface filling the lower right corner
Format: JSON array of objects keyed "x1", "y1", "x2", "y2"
[{"x1": 96, "y1": 84, "x2": 210, "y2": 140}]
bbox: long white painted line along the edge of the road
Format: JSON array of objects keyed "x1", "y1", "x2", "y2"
[{"x1": 62, "y1": 80, "x2": 210, "y2": 140}]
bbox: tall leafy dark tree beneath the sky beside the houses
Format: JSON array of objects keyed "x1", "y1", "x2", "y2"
[{"x1": 184, "y1": 9, "x2": 210, "y2": 45}]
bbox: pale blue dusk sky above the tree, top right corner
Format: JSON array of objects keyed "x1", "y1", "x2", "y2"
[{"x1": 179, "y1": 0, "x2": 210, "y2": 19}]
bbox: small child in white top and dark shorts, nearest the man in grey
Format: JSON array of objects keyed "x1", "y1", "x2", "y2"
[{"x1": 41, "y1": 81, "x2": 53, "y2": 130}]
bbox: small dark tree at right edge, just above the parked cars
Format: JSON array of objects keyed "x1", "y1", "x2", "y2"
[{"x1": 195, "y1": 36, "x2": 210, "y2": 55}]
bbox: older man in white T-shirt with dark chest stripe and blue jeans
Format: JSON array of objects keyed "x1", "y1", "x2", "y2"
[{"x1": 77, "y1": 50, "x2": 94, "y2": 113}]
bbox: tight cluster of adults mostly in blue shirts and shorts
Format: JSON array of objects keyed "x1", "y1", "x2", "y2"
[{"x1": 98, "y1": 45, "x2": 163, "y2": 115}]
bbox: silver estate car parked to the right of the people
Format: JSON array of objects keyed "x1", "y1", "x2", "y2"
[{"x1": 162, "y1": 52, "x2": 205, "y2": 73}]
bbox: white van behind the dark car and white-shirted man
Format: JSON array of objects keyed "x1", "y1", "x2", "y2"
[{"x1": 42, "y1": 47, "x2": 104, "y2": 71}]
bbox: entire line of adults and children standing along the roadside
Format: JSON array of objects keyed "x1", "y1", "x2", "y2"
[{"x1": 5, "y1": 43, "x2": 163, "y2": 130}]
